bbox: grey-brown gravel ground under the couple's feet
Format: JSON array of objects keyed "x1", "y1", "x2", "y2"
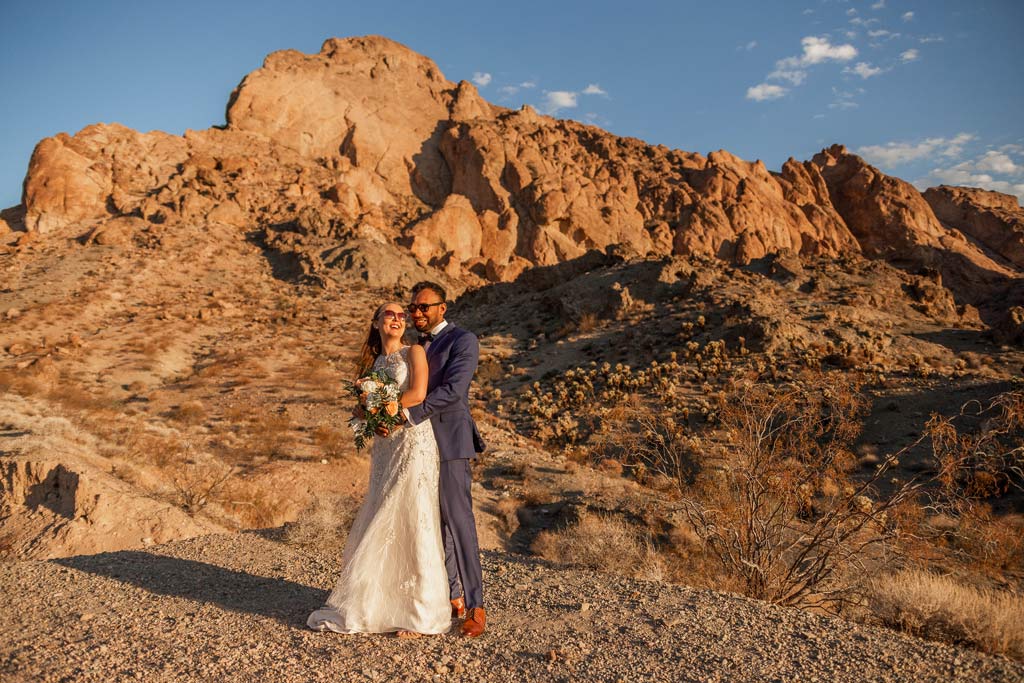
[{"x1": 0, "y1": 531, "x2": 1024, "y2": 683}]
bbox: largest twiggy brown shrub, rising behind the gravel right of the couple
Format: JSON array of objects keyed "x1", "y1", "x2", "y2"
[{"x1": 682, "y1": 373, "x2": 920, "y2": 608}]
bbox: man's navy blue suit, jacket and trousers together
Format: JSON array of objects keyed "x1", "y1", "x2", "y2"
[{"x1": 409, "y1": 323, "x2": 484, "y2": 609}]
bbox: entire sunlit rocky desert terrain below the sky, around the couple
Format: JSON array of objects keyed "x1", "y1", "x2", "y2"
[{"x1": 0, "y1": 37, "x2": 1024, "y2": 681}]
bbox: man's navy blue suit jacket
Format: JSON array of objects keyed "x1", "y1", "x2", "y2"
[{"x1": 409, "y1": 322, "x2": 485, "y2": 461}]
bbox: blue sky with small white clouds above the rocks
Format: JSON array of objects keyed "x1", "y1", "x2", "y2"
[{"x1": 0, "y1": 0, "x2": 1024, "y2": 207}]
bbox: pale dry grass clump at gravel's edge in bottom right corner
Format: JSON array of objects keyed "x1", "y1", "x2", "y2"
[{"x1": 868, "y1": 569, "x2": 1024, "y2": 658}]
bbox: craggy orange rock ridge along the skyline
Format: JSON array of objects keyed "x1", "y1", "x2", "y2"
[{"x1": 12, "y1": 37, "x2": 1024, "y2": 304}]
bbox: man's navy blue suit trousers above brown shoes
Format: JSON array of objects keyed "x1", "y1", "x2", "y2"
[{"x1": 439, "y1": 458, "x2": 483, "y2": 608}]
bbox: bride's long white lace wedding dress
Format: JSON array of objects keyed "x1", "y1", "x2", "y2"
[{"x1": 306, "y1": 346, "x2": 452, "y2": 634}]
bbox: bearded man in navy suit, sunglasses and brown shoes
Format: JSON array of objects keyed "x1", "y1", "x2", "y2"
[{"x1": 404, "y1": 283, "x2": 486, "y2": 638}]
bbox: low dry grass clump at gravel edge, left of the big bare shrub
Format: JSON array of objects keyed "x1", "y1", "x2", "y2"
[{"x1": 532, "y1": 513, "x2": 665, "y2": 580}]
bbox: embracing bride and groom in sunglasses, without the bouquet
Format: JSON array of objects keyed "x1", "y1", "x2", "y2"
[{"x1": 307, "y1": 283, "x2": 485, "y2": 637}]
